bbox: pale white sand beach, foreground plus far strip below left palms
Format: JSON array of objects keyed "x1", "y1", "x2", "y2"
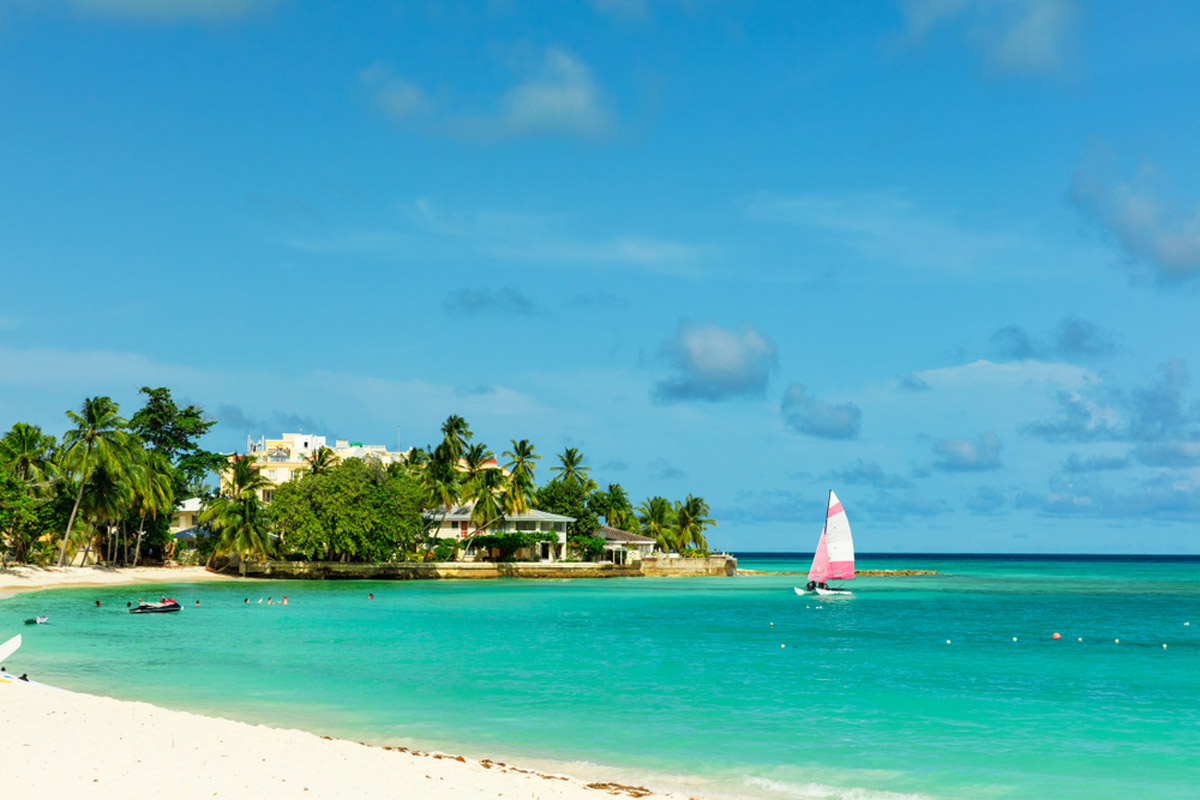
[{"x1": 0, "y1": 566, "x2": 705, "y2": 800}]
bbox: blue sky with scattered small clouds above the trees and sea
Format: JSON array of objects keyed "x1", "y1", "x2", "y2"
[{"x1": 0, "y1": 0, "x2": 1200, "y2": 553}]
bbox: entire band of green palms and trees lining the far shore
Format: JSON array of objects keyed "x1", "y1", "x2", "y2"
[{"x1": 0, "y1": 398, "x2": 716, "y2": 566}]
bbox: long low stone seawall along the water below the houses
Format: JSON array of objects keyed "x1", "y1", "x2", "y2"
[{"x1": 229, "y1": 555, "x2": 738, "y2": 581}]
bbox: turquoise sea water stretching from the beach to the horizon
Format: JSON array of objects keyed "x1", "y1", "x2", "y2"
[{"x1": 0, "y1": 554, "x2": 1200, "y2": 800}]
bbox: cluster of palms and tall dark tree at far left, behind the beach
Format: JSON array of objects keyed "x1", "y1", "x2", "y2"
[{"x1": 0, "y1": 387, "x2": 224, "y2": 566}]
